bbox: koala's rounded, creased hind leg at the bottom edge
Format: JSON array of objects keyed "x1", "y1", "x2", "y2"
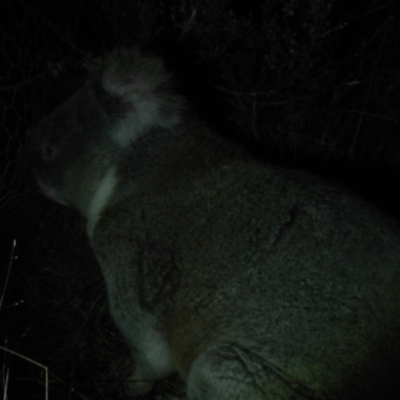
[{"x1": 187, "y1": 344, "x2": 310, "y2": 400}]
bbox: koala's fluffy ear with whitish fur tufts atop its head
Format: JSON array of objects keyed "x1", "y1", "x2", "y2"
[{"x1": 101, "y1": 49, "x2": 184, "y2": 146}]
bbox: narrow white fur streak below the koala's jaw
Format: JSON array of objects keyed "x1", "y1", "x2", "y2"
[{"x1": 87, "y1": 167, "x2": 117, "y2": 237}]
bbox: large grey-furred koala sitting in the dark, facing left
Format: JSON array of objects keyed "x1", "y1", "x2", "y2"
[{"x1": 25, "y1": 48, "x2": 400, "y2": 400}]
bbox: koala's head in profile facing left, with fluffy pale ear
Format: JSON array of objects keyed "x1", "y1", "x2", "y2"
[{"x1": 24, "y1": 49, "x2": 183, "y2": 215}]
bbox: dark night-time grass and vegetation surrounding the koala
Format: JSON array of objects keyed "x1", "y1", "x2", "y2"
[{"x1": 0, "y1": 0, "x2": 400, "y2": 400}]
